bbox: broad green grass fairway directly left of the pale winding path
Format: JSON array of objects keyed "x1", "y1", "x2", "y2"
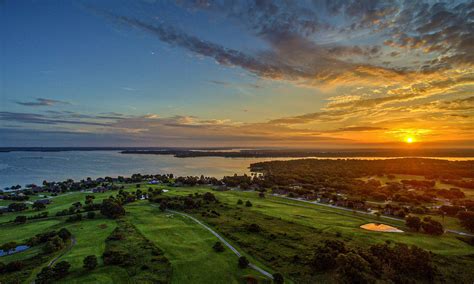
[{"x1": 127, "y1": 201, "x2": 266, "y2": 283}]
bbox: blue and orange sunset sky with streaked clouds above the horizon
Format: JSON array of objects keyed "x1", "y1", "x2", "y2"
[{"x1": 0, "y1": 0, "x2": 474, "y2": 148}]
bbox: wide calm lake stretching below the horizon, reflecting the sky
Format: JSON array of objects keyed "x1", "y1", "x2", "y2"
[{"x1": 0, "y1": 151, "x2": 472, "y2": 188}]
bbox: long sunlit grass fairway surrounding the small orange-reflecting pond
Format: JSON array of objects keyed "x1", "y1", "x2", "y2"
[{"x1": 160, "y1": 188, "x2": 474, "y2": 255}]
